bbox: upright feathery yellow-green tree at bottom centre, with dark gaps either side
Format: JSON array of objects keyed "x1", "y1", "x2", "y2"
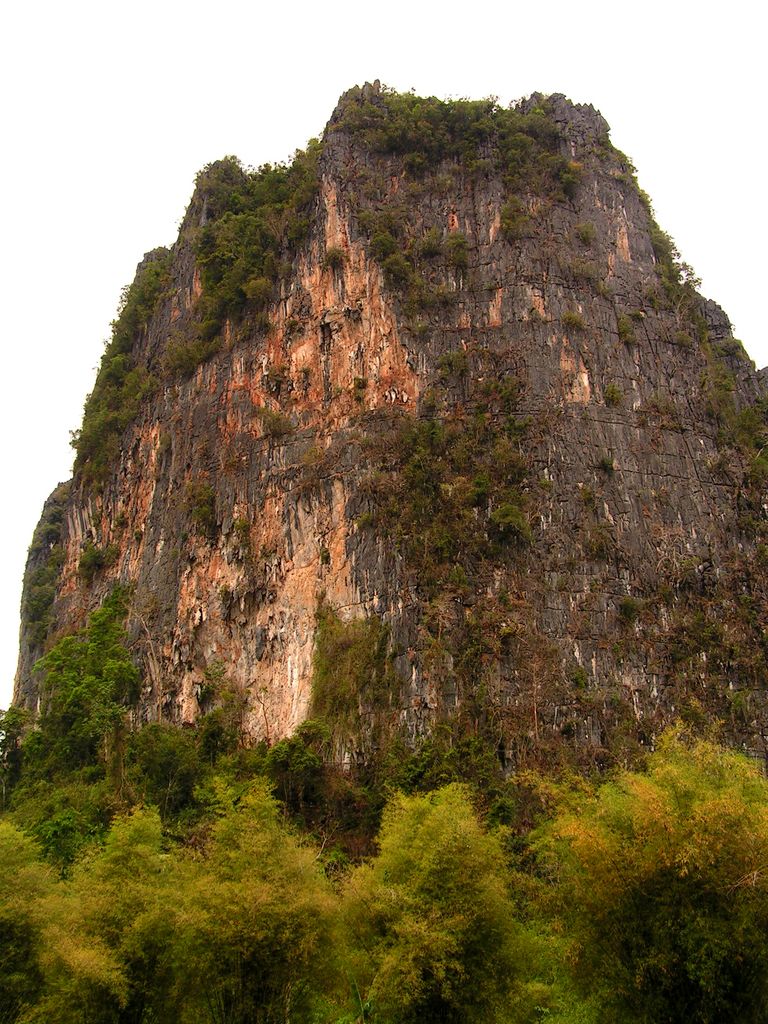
[{"x1": 345, "y1": 784, "x2": 530, "y2": 1024}]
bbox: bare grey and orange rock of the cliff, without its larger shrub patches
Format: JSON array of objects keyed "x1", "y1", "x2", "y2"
[{"x1": 15, "y1": 90, "x2": 766, "y2": 761}]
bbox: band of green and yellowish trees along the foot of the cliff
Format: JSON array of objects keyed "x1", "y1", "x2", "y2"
[{"x1": 0, "y1": 590, "x2": 768, "y2": 1024}]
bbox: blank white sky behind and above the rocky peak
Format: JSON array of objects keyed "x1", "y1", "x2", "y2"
[{"x1": 0, "y1": 0, "x2": 768, "y2": 708}]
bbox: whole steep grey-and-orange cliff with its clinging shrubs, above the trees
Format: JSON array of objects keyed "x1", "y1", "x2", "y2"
[{"x1": 15, "y1": 86, "x2": 768, "y2": 758}]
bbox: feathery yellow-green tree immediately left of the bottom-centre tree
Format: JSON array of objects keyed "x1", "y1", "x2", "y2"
[{"x1": 176, "y1": 782, "x2": 334, "y2": 1024}]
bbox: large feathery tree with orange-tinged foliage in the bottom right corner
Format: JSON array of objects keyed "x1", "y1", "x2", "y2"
[{"x1": 539, "y1": 734, "x2": 768, "y2": 1024}]
